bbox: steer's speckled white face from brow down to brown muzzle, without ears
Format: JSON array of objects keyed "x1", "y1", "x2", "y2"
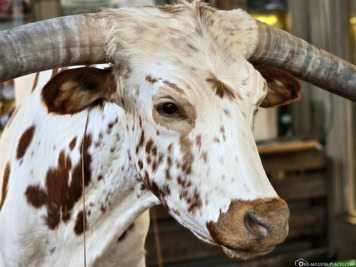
[{"x1": 124, "y1": 58, "x2": 289, "y2": 258}]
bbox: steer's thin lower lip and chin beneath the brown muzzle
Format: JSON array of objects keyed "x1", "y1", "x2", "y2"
[{"x1": 221, "y1": 246, "x2": 275, "y2": 260}]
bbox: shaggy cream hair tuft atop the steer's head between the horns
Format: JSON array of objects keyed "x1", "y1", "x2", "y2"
[{"x1": 104, "y1": 4, "x2": 257, "y2": 72}]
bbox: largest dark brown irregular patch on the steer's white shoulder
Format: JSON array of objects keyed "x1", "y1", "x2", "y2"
[{"x1": 25, "y1": 135, "x2": 92, "y2": 230}]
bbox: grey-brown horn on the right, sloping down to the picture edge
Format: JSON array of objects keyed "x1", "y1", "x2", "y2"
[{"x1": 249, "y1": 21, "x2": 356, "y2": 101}]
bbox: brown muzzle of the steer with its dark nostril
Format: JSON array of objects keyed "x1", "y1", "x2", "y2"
[{"x1": 207, "y1": 198, "x2": 289, "y2": 258}]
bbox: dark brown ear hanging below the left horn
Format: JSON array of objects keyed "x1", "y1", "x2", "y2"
[{"x1": 42, "y1": 67, "x2": 116, "y2": 115}]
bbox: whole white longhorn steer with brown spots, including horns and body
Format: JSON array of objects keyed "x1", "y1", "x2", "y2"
[{"x1": 0, "y1": 1, "x2": 356, "y2": 266}]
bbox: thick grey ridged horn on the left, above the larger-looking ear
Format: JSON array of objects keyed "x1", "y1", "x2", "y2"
[{"x1": 0, "y1": 13, "x2": 108, "y2": 81}]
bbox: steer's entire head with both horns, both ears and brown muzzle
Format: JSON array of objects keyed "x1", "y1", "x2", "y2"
[{"x1": 0, "y1": 1, "x2": 355, "y2": 259}]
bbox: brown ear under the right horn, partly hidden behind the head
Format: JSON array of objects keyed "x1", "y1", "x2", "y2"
[{"x1": 255, "y1": 65, "x2": 302, "y2": 108}]
